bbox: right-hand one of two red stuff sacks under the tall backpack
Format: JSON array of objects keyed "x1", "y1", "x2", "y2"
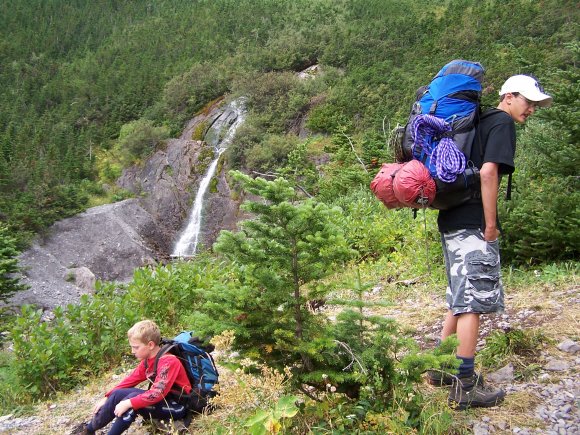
[{"x1": 393, "y1": 160, "x2": 436, "y2": 208}]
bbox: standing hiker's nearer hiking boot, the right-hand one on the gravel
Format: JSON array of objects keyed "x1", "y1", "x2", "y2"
[{"x1": 448, "y1": 374, "x2": 505, "y2": 410}]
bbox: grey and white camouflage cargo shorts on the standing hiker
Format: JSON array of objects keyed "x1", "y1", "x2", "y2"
[{"x1": 441, "y1": 229, "x2": 504, "y2": 315}]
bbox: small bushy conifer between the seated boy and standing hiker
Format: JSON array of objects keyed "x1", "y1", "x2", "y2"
[{"x1": 214, "y1": 172, "x2": 351, "y2": 372}]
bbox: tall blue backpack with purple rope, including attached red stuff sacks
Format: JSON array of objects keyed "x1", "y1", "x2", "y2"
[{"x1": 371, "y1": 60, "x2": 484, "y2": 210}]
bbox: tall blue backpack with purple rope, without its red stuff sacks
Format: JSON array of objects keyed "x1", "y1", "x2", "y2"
[{"x1": 397, "y1": 60, "x2": 484, "y2": 209}]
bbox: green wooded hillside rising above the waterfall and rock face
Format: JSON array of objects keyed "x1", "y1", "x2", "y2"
[{"x1": 0, "y1": 0, "x2": 578, "y2": 258}]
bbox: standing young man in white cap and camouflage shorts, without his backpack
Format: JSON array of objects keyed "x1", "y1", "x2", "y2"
[{"x1": 429, "y1": 75, "x2": 552, "y2": 409}]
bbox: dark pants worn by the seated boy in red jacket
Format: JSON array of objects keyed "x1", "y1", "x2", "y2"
[{"x1": 90, "y1": 388, "x2": 187, "y2": 435}]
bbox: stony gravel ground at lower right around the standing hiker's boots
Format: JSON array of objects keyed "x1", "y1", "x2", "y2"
[{"x1": 419, "y1": 286, "x2": 580, "y2": 435}]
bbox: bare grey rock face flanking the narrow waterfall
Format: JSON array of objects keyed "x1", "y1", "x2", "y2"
[{"x1": 9, "y1": 99, "x2": 245, "y2": 309}]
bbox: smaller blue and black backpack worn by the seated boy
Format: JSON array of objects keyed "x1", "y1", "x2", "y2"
[{"x1": 145, "y1": 331, "x2": 219, "y2": 423}]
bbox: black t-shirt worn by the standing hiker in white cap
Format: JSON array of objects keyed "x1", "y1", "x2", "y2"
[{"x1": 437, "y1": 109, "x2": 516, "y2": 232}]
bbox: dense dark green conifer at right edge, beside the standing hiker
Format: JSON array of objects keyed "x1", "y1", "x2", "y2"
[{"x1": 501, "y1": 58, "x2": 580, "y2": 262}]
